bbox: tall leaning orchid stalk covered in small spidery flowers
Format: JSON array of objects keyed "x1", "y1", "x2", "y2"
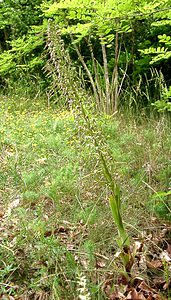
[{"x1": 46, "y1": 24, "x2": 132, "y2": 271}]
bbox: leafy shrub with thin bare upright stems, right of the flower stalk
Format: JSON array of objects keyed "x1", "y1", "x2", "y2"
[{"x1": 42, "y1": 1, "x2": 170, "y2": 113}]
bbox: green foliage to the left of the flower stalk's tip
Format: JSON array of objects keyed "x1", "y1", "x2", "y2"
[{"x1": 0, "y1": 0, "x2": 46, "y2": 85}]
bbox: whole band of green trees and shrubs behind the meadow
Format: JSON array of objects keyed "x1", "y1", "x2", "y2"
[{"x1": 0, "y1": 0, "x2": 170, "y2": 112}]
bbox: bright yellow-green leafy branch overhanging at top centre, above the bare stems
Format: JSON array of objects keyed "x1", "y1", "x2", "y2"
[{"x1": 45, "y1": 0, "x2": 135, "y2": 37}]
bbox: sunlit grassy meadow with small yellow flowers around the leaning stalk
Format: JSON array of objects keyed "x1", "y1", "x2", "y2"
[{"x1": 0, "y1": 97, "x2": 171, "y2": 299}]
